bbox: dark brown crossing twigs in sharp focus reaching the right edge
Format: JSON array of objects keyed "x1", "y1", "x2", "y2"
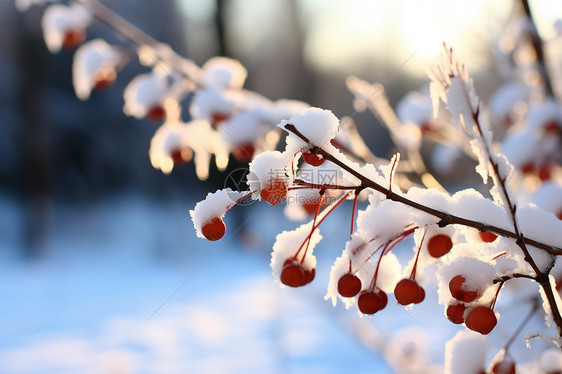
[{"x1": 284, "y1": 122, "x2": 562, "y2": 336}]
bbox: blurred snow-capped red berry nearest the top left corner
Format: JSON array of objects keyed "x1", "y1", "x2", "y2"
[{"x1": 41, "y1": 3, "x2": 92, "y2": 53}]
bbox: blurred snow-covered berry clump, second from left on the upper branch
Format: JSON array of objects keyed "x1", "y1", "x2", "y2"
[{"x1": 72, "y1": 39, "x2": 121, "y2": 100}]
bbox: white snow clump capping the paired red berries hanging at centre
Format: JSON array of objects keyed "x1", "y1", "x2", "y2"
[{"x1": 271, "y1": 222, "x2": 322, "y2": 279}]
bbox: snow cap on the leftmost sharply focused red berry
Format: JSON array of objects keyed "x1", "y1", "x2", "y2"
[{"x1": 189, "y1": 188, "x2": 245, "y2": 240}]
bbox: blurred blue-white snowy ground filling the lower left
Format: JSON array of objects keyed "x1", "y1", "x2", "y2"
[{"x1": 0, "y1": 196, "x2": 398, "y2": 374}]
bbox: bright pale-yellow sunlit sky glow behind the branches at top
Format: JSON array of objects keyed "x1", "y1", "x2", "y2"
[{"x1": 302, "y1": 0, "x2": 512, "y2": 75}]
